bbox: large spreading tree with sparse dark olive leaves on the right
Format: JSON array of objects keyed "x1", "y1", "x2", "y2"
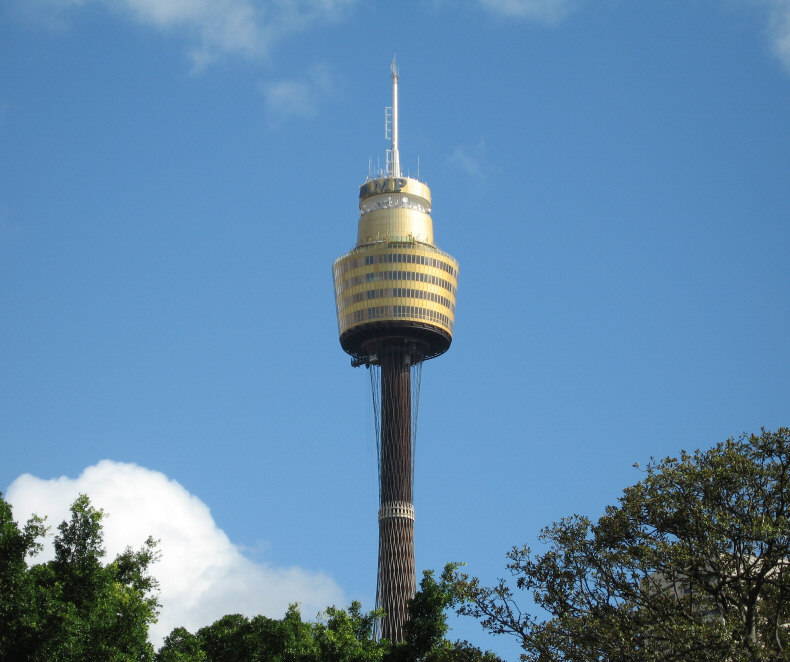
[{"x1": 455, "y1": 428, "x2": 790, "y2": 662}]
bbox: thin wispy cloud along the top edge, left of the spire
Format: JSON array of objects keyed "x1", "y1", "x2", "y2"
[{"x1": 17, "y1": 0, "x2": 355, "y2": 68}]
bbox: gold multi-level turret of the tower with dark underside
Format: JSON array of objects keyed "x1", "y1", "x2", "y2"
[{"x1": 333, "y1": 177, "x2": 458, "y2": 362}]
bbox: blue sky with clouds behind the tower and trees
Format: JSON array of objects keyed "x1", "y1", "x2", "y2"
[{"x1": 0, "y1": 0, "x2": 790, "y2": 659}]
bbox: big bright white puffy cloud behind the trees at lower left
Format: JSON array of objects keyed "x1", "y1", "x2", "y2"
[{"x1": 6, "y1": 460, "x2": 345, "y2": 646}]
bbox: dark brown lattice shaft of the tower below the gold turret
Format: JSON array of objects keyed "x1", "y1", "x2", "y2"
[{"x1": 376, "y1": 341, "x2": 417, "y2": 642}]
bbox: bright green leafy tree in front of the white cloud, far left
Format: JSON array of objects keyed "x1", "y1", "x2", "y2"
[{"x1": 0, "y1": 495, "x2": 159, "y2": 662}]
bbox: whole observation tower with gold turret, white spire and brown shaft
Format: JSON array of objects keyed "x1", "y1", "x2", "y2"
[{"x1": 332, "y1": 60, "x2": 458, "y2": 642}]
